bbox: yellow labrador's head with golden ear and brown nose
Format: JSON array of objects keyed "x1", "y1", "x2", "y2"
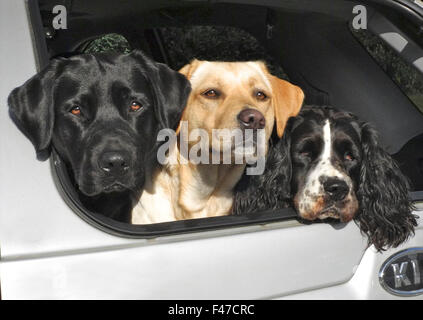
[{"x1": 178, "y1": 60, "x2": 304, "y2": 158}]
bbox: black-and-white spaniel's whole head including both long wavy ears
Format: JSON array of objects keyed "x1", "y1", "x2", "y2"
[{"x1": 234, "y1": 106, "x2": 417, "y2": 250}]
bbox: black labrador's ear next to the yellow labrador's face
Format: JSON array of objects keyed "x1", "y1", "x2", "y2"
[{"x1": 130, "y1": 50, "x2": 191, "y2": 129}]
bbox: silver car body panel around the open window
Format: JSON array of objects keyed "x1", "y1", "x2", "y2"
[{"x1": 0, "y1": 0, "x2": 423, "y2": 299}]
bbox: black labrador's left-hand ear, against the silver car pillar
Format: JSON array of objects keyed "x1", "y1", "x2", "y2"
[{"x1": 8, "y1": 61, "x2": 63, "y2": 161}]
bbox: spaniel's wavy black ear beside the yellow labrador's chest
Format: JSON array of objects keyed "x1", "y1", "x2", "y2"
[{"x1": 232, "y1": 130, "x2": 292, "y2": 215}]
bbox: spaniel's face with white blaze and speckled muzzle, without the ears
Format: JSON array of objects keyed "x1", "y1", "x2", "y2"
[{"x1": 291, "y1": 107, "x2": 363, "y2": 222}]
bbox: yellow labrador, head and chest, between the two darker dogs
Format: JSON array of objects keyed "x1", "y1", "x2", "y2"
[{"x1": 132, "y1": 60, "x2": 304, "y2": 224}]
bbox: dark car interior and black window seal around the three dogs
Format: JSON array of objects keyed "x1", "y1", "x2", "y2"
[{"x1": 29, "y1": 0, "x2": 423, "y2": 237}]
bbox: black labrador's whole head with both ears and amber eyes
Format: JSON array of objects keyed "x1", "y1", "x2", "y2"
[{"x1": 8, "y1": 51, "x2": 190, "y2": 196}]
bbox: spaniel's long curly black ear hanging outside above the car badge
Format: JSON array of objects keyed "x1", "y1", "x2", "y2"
[{"x1": 355, "y1": 123, "x2": 417, "y2": 251}]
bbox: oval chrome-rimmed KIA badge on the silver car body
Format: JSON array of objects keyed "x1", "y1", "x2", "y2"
[{"x1": 379, "y1": 248, "x2": 423, "y2": 296}]
